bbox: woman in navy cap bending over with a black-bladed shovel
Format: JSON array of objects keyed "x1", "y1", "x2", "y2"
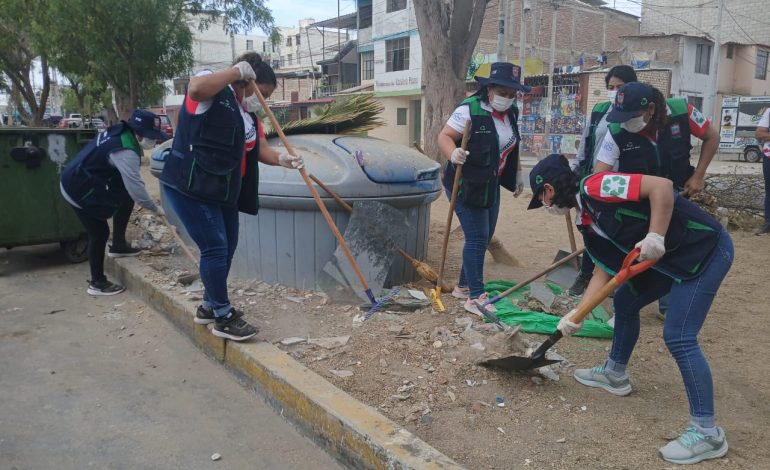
[{"x1": 529, "y1": 155, "x2": 733, "y2": 464}]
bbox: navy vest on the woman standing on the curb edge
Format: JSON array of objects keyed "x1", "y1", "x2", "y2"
[{"x1": 160, "y1": 87, "x2": 245, "y2": 205}]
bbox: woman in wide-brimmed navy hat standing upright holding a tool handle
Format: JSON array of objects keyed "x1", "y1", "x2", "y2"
[{"x1": 438, "y1": 62, "x2": 529, "y2": 316}]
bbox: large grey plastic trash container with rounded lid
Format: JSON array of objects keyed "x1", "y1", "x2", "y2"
[{"x1": 152, "y1": 134, "x2": 441, "y2": 289}]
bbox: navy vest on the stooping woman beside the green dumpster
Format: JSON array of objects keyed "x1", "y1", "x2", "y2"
[{"x1": 61, "y1": 121, "x2": 142, "y2": 220}]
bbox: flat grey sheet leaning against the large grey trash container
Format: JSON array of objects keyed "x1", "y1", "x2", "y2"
[{"x1": 318, "y1": 201, "x2": 408, "y2": 303}]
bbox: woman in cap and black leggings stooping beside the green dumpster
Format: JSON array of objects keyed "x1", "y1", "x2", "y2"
[{"x1": 60, "y1": 109, "x2": 168, "y2": 295}]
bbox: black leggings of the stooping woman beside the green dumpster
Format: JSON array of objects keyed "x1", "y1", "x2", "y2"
[{"x1": 74, "y1": 195, "x2": 134, "y2": 282}]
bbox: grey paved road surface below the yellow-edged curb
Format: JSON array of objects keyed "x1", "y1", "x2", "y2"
[{"x1": 0, "y1": 245, "x2": 341, "y2": 470}]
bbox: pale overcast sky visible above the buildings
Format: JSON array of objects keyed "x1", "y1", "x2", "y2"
[{"x1": 267, "y1": 0, "x2": 642, "y2": 28}]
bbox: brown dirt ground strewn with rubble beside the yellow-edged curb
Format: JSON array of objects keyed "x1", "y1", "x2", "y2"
[{"x1": 131, "y1": 166, "x2": 770, "y2": 469}]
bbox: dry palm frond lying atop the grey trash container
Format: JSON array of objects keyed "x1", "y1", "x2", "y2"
[{"x1": 263, "y1": 94, "x2": 384, "y2": 138}]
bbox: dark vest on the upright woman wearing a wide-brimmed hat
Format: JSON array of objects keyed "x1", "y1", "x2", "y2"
[{"x1": 443, "y1": 95, "x2": 521, "y2": 208}]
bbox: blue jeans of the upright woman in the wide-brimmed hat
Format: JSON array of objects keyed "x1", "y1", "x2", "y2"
[{"x1": 445, "y1": 186, "x2": 500, "y2": 299}]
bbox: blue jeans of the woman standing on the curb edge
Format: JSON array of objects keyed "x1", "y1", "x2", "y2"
[{"x1": 161, "y1": 184, "x2": 238, "y2": 317}]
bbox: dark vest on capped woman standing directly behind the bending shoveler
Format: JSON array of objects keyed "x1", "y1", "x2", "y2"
[{"x1": 609, "y1": 98, "x2": 694, "y2": 188}]
